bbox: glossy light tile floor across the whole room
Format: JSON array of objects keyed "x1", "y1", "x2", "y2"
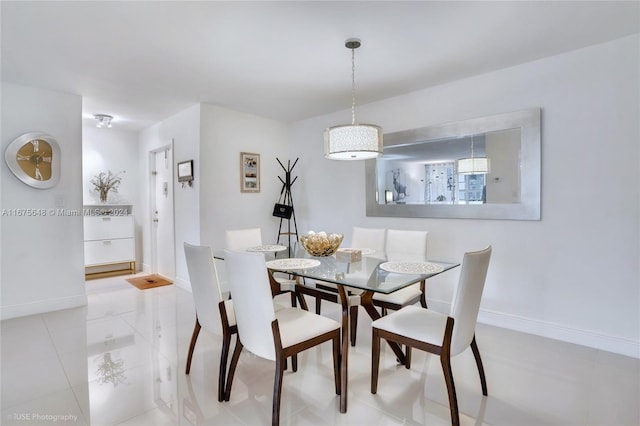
[{"x1": 0, "y1": 277, "x2": 640, "y2": 426}]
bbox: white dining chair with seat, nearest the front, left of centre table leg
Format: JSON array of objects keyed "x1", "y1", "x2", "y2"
[{"x1": 224, "y1": 250, "x2": 341, "y2": 425}]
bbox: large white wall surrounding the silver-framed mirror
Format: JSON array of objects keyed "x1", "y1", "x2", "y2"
[{"x1": 289, "y1": 35, "x2": 640, "y2": 357}]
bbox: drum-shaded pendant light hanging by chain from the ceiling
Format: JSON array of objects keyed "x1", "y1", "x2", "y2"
[{"x1": 324, "y1": 38, "x2": 382, "y2": 160}]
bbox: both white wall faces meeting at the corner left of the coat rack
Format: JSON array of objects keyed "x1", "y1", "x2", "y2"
[{"x1": 139, "y1": 104, "x2": 289, "y2": 289}]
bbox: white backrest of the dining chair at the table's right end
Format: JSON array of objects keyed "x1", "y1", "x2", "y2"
[{"x1": 450, "y1": 246, "x2": 491, "y2": 356}]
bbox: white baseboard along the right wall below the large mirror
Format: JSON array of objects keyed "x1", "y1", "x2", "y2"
[{"x1": 428, "y1": 300, "x2": 640, "y2": 358}]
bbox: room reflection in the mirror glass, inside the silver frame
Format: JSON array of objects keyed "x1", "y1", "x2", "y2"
[{"x1": 376, "y1": 129, "x2": 521, "y2": 204}]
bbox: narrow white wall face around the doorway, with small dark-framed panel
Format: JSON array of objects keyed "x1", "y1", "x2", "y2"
[{"x1": 137, "y1": 105, "x2": 200, "y2": 288}]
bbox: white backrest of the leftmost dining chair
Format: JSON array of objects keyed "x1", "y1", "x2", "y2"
[{"x1": 184, "y1": 243, "x2": 222, "y2": 334}]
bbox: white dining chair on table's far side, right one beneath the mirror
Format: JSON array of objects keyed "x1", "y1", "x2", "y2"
[{"x1": 373, "y1": 229, "x2": 429, "y2": 314}]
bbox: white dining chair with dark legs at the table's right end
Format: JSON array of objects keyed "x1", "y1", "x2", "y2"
[{"x1": 371, "y1": 246, "x2": 491, "y2": 426}]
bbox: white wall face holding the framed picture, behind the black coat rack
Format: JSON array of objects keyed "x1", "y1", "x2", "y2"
[{"x1": 199, "y1": 104, "x2": 292, "y2": 253}]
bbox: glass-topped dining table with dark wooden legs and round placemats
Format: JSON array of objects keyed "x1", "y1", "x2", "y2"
[{"x1": 266, "y1": 245, "x2": 460, "y2": 413}]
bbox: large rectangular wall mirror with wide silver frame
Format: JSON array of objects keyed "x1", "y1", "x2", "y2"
[{"x1": 365, "y1": 108, "x2": 541, "y2": 220}]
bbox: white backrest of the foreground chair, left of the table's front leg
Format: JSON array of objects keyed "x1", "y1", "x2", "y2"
[{"x1": 224, "y1": 250, "x2": 276, "y2": 360}]
